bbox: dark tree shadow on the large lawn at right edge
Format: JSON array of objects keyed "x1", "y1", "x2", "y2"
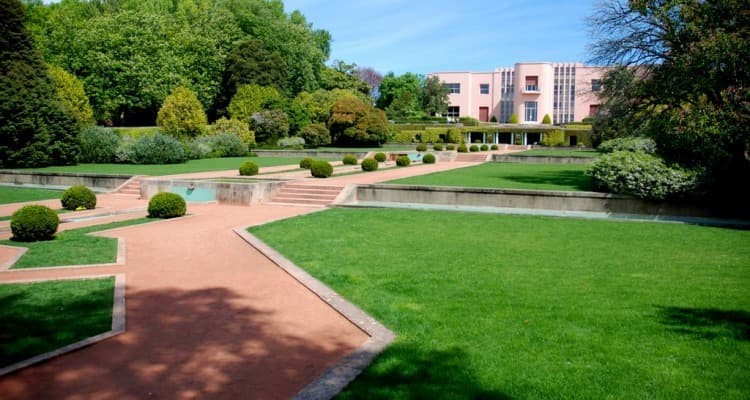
[{"x1": 657, "y1": 306, "x2": 750, "y2": 341}]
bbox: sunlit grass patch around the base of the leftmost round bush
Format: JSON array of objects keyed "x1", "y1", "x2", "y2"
[{"x1": 0, "y1": 218, "x2": 154, "y2": 269}]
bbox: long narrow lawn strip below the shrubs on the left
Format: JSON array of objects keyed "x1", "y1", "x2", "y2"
[{"x1": 3, "y1": 157, "x2": 300, "y2": 176}]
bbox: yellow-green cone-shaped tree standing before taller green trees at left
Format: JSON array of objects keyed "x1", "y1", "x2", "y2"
[{"x1": 156, "y1": 87, "x2": 208, "y2": 138}]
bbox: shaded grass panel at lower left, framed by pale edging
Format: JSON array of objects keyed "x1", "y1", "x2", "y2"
[{"x1": 0, "y1": 278, "x2": 114, "y2": 367}]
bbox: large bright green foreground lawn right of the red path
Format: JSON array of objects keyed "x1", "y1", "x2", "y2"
[{"x1": 251, "y1": 209, "x2": 750, "y2": 399}]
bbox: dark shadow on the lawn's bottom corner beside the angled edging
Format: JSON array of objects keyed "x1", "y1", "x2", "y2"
[{"x1": 337, "y1": 343, "x2": 511, "y2": 400}]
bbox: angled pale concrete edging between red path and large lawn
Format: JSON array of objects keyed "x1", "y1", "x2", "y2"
[{"x1": 234, "y1": 227, "x2": 396, "y2": 400}]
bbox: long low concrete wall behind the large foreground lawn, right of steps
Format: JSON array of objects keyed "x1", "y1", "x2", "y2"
[{"x1": 350, "y1": 184, "x2": 715, "y2": 217}]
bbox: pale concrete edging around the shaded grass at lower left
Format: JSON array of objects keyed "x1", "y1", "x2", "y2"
[{"x1": 0, "y1": 274, "x2": 126, "y2": 376}]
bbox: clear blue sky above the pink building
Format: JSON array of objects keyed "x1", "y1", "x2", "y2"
[{"x1": 284, "y1": 0, "x2": 595, "y2": 74}]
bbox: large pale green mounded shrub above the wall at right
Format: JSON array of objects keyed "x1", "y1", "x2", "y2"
[{"x1": 586, "y1": 151, "x2": 697, "y2": 200}]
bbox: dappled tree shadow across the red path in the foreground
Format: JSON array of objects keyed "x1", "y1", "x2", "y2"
[{"x1": 0, "y1": 288, "x2": 364, "y2": 399}]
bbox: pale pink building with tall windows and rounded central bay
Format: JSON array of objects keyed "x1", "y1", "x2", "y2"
[{"x1": 429, "y1": 62, "x2": 605, "y2": 124}]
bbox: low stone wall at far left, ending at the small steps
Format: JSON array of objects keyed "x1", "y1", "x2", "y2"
[{"x1": 0, "y1": 171, "x2": 131, "y2": 192}]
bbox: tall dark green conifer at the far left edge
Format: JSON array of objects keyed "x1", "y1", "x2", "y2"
[{"x1": 0, "y1": 0, "x2": 79, "y2": 168}]
